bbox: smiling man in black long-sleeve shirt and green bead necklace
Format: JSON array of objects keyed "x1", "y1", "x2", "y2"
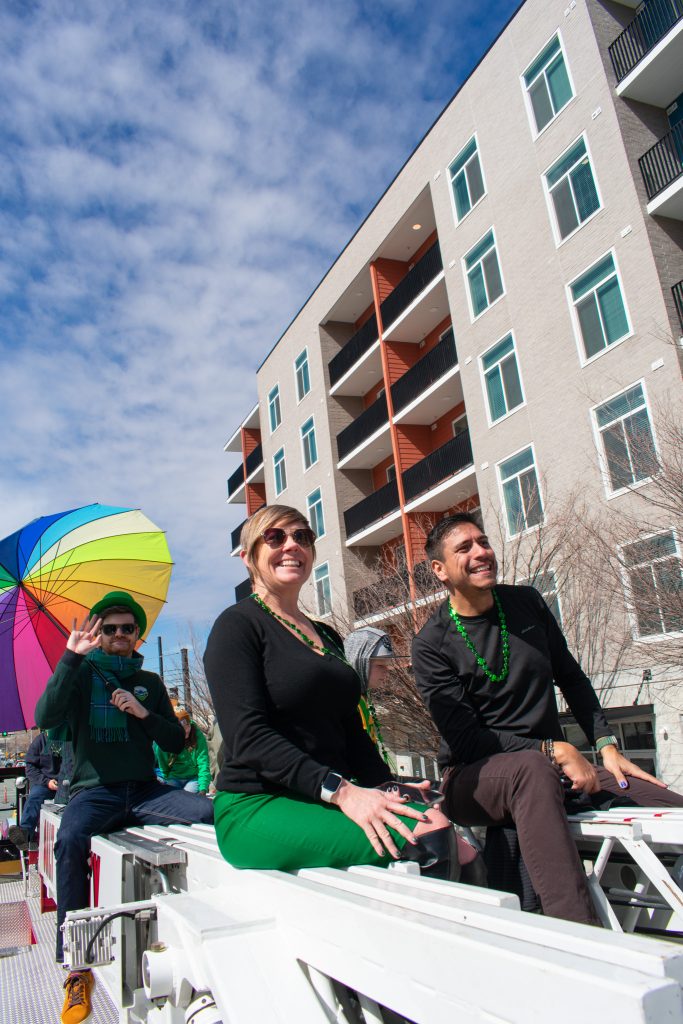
[{"x1": 413, "y1": 514, "x2": 683, "y2": 924}]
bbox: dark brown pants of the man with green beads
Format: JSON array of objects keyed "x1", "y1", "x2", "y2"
[{"x1": 443, "y1": 751, "x2": 683, "y2": 925}]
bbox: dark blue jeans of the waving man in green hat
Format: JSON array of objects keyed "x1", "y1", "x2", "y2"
[{"x1": 54, "y1": 780, "x2": 213, "y2": 961}]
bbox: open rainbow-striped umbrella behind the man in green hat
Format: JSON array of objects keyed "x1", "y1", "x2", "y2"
[{"x1": 0, "y1": 505, "x2": 173, "y2": 731}]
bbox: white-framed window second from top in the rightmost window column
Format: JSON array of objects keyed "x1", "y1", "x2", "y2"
[{"x1": 543, "y1": 136, "x2": 601, "y2": 243}]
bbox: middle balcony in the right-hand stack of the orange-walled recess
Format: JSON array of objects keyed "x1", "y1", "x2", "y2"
[{"x1": 391, "y1": 330, "x2": 463, "y2": 423}]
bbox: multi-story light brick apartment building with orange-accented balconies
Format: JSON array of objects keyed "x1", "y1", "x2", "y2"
[{"x1": 225, "y1": 0, "x2": 683, "y2": 783}]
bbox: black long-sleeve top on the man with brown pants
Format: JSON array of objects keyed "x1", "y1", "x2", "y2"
[{"x1": 413, "y1": 586, "x2": 611, "y2": 765}]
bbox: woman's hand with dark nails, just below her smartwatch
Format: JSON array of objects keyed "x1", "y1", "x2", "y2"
[{"x1": 332, "y1": 780, "x2": 429, "y2": 859}]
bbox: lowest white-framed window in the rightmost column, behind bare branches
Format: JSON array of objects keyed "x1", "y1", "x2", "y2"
[{"x1": 622, "y1": 529, "x2": 683, "y2": 638}]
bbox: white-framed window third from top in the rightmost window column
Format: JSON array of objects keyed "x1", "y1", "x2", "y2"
[{"x1": 568, "y1": 252, "x2": 632, "y2": 361}]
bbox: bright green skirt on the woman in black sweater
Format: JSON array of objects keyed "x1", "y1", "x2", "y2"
[{"x1": 213, "y1": 793, "x2": 424, "y2": 871}]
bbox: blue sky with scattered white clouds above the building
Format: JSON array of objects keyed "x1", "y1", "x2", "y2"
[{"x1": 0, "y1": 0, "x2": 517, "y2": 668}]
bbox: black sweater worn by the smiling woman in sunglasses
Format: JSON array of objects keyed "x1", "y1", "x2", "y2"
[{"x1": 204, "y1": 600, "x2": 391, "y2": 800}]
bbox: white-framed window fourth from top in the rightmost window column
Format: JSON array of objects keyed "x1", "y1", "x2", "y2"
[{"x1": 593, "y1": 384, "x2": 658, "y2": 494}]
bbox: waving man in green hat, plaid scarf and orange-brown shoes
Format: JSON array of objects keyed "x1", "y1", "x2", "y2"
[{"x1": 36, "y1": 591, "x2": 213, "y2": 1024}]
